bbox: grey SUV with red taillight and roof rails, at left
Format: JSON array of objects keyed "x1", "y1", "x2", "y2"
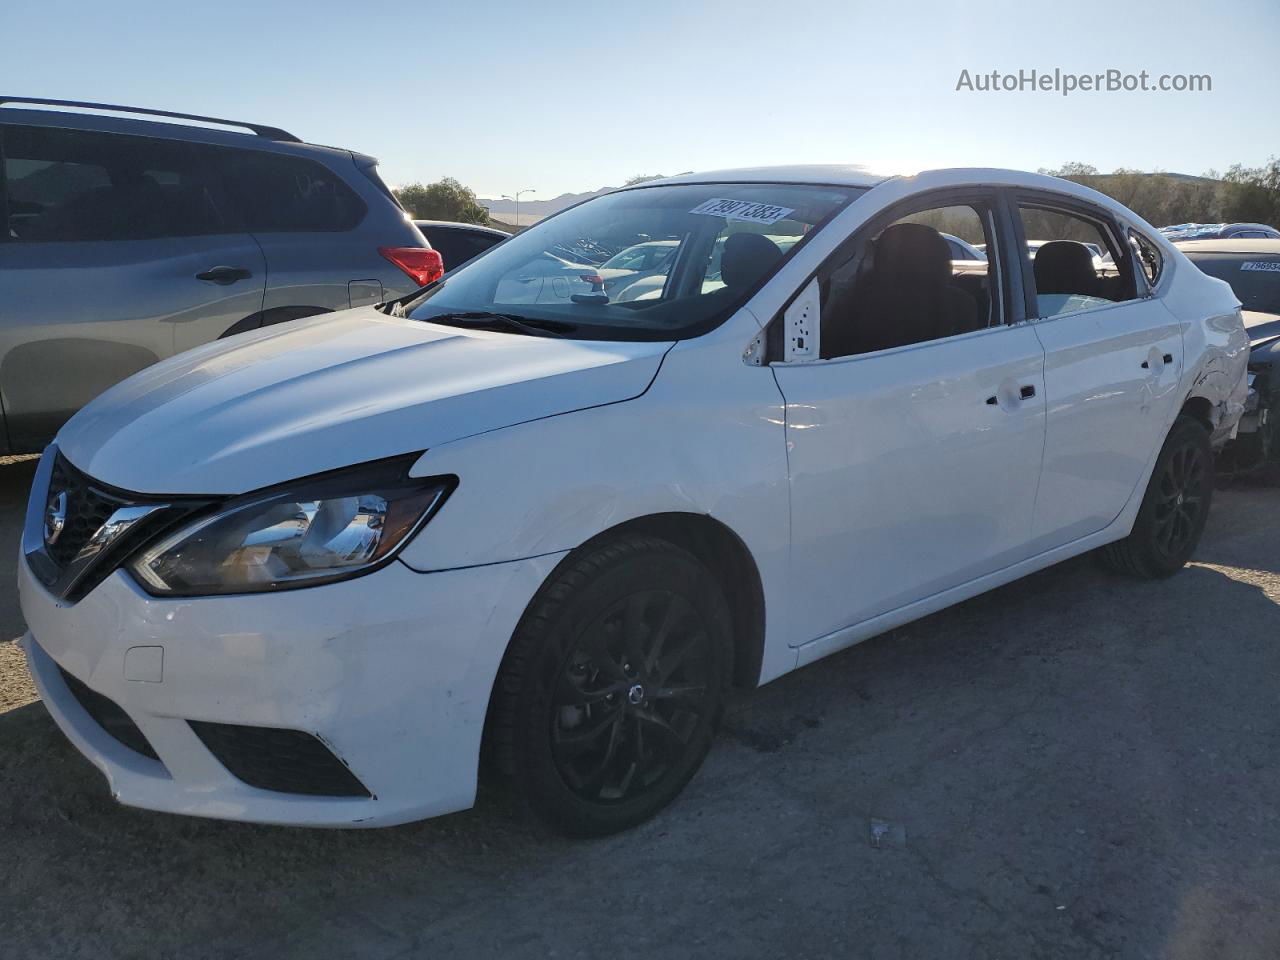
[{"x1": 0, "y1": 97, "x2": 442, "y2": 453}]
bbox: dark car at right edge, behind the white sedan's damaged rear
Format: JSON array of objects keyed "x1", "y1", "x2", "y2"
[{"x1": 1176, "y1": 238, "x2": 1280, "y2": 481}]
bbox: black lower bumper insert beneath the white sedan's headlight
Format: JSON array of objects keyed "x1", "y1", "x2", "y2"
[{"x1": 188, "y1": 721, "x2": 371, "y2": 796}]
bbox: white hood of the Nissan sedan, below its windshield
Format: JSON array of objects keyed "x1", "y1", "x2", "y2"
[{"x1": 56, "y1": 308, "x2": 671, "y2": 494}]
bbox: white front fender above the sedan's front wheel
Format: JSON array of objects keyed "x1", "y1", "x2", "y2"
[{"x1": 401, "y1": 312, "x2": 795, "y2": 680}]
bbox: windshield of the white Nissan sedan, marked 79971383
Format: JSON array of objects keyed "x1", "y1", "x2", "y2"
[{"x1": 406, "y1": 183, "x2": 861, "y2": 340}]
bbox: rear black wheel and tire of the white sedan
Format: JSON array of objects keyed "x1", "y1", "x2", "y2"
[{"x1": 1101, "y1": 416, "x2": 1213, "y2": 580}]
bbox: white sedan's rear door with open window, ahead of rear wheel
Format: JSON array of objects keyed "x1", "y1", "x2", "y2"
[{"x1": 1012, "y1": 192, "x2": 1183, "y2": 549}]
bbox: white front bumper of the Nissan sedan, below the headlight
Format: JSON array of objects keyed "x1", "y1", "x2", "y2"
[{"x1": 18, "y1": 554, "x2": 562, "y2": 827}]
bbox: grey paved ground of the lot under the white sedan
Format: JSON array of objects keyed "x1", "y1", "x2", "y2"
[{"x1": 0, "y1": 462, "x2": 1280, "y2": 960}]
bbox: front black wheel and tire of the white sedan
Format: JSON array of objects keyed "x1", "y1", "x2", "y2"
[{"x1": 489, "y1": 536, "x2": 732, "y2": 837}]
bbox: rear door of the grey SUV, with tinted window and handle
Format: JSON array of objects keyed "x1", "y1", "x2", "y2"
[{"x1": 0, "y1": 124, "x2": 266, "y2": 451}]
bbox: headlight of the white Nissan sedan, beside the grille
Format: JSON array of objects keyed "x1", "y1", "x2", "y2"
[{"x1": 128, "y1": 454, "x2": 454, "y2": 595}]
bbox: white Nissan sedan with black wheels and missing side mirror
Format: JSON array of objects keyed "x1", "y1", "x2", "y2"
[{"x1": 18, "y1": 166, "x2": 1249, "y2": 835}]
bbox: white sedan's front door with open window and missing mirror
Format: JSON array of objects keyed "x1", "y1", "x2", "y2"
[{"x1": 772, "y1": 197, "x2": 1044, "y2": 643}]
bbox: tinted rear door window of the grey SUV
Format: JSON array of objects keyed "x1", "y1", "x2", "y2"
[{"x1": 3, "y1": 125, "x2": 233, "y2": 243}]
